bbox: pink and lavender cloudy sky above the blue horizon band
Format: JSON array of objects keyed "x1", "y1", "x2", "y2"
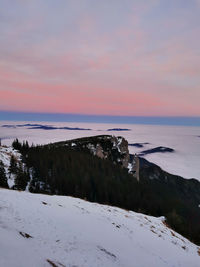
[{"x1": 0, "y1": 0, "x2": 200, "y2": 116}]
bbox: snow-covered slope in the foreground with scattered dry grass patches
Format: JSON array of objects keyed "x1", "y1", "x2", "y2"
[{"x1": 0, "y1": 189, "x2": 200, "y2": 267}]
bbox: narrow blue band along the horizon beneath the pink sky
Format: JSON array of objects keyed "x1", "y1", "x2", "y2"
[{"x1": 0, "y1": 110, "x2": 200, "y2": 126}]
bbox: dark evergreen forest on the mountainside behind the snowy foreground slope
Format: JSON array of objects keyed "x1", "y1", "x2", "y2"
[{"x1": 0, "y1": 140, "x2": 200, "y2": 244}]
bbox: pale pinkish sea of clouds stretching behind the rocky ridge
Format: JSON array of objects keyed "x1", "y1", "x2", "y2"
[{"x1": 0, "y1": 121, "x2": 200, "y2": 180}]
